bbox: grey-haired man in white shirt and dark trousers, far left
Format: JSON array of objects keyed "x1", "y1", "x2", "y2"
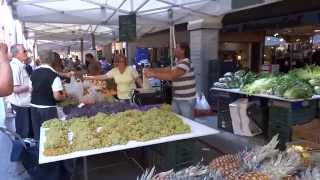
[{"x1": 7, "y1": 44, "x2": 33, "y2": 138}]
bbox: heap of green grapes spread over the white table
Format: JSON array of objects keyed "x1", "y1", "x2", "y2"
[{"x1": 42, "y1": 105, "x2": 191, "y2": 156}]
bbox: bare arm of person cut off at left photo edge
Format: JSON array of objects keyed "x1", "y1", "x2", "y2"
[{"x1": 0, "y1": 43, "x2": 13, "y2": 96}]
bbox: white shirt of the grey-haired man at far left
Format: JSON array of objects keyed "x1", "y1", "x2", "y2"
[{"x1": 7, "y1": 58, "x2": 31, "y2": 107}]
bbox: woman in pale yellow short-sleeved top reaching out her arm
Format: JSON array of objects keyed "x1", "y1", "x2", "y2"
[{"x1": 85, "y1": 55, "x2": 142, "y2": 100}]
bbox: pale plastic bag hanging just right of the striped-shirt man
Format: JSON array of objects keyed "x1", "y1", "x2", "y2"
[{"x1": 194, "y1": 93, "x2": 213, "y2": 117}]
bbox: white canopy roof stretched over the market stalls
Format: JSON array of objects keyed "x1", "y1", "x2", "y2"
[{"x1": 13, "y1": 0, "x2": 278, "y2": 49}]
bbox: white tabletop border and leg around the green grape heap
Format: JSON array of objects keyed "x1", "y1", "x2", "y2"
[{"x1": 39, "y1": 115, "x2": 219, "y2": 179}]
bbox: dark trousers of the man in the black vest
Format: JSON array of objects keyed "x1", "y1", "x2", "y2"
[{"x1": 31, "y1": 107, "x2": 58, "y2": 140}]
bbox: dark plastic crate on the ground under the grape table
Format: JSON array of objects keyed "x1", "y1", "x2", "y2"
[{"x1": 147, "y1": 139, "x2": 200, "y2": 171}]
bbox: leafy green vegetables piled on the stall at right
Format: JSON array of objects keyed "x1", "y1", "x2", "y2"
[{"x1": 214, "y1": 66, "x2": 320, "y2": 99}]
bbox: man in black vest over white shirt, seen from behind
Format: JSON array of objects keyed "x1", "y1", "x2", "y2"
[{"x1": 31, "y1": 50, "x2": 65, "y2": 140}]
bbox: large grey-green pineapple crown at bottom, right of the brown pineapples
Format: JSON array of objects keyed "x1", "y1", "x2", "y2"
[{"x1": 259, "y1": 150, "x2": 303, "y2": 180}]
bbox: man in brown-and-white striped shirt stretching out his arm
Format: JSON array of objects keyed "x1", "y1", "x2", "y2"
[{"x1": 144, "y1": 43, "x2": 196, "y2": 119}]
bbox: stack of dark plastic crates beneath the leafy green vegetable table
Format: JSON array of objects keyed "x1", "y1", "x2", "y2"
[{"x1": 269, "y1": 100, "x2": 317, "y2": 149}]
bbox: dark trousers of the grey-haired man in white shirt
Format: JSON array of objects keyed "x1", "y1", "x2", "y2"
[{"x1": 12, "y1": 104, "x2": 33, "y2": 138}]
